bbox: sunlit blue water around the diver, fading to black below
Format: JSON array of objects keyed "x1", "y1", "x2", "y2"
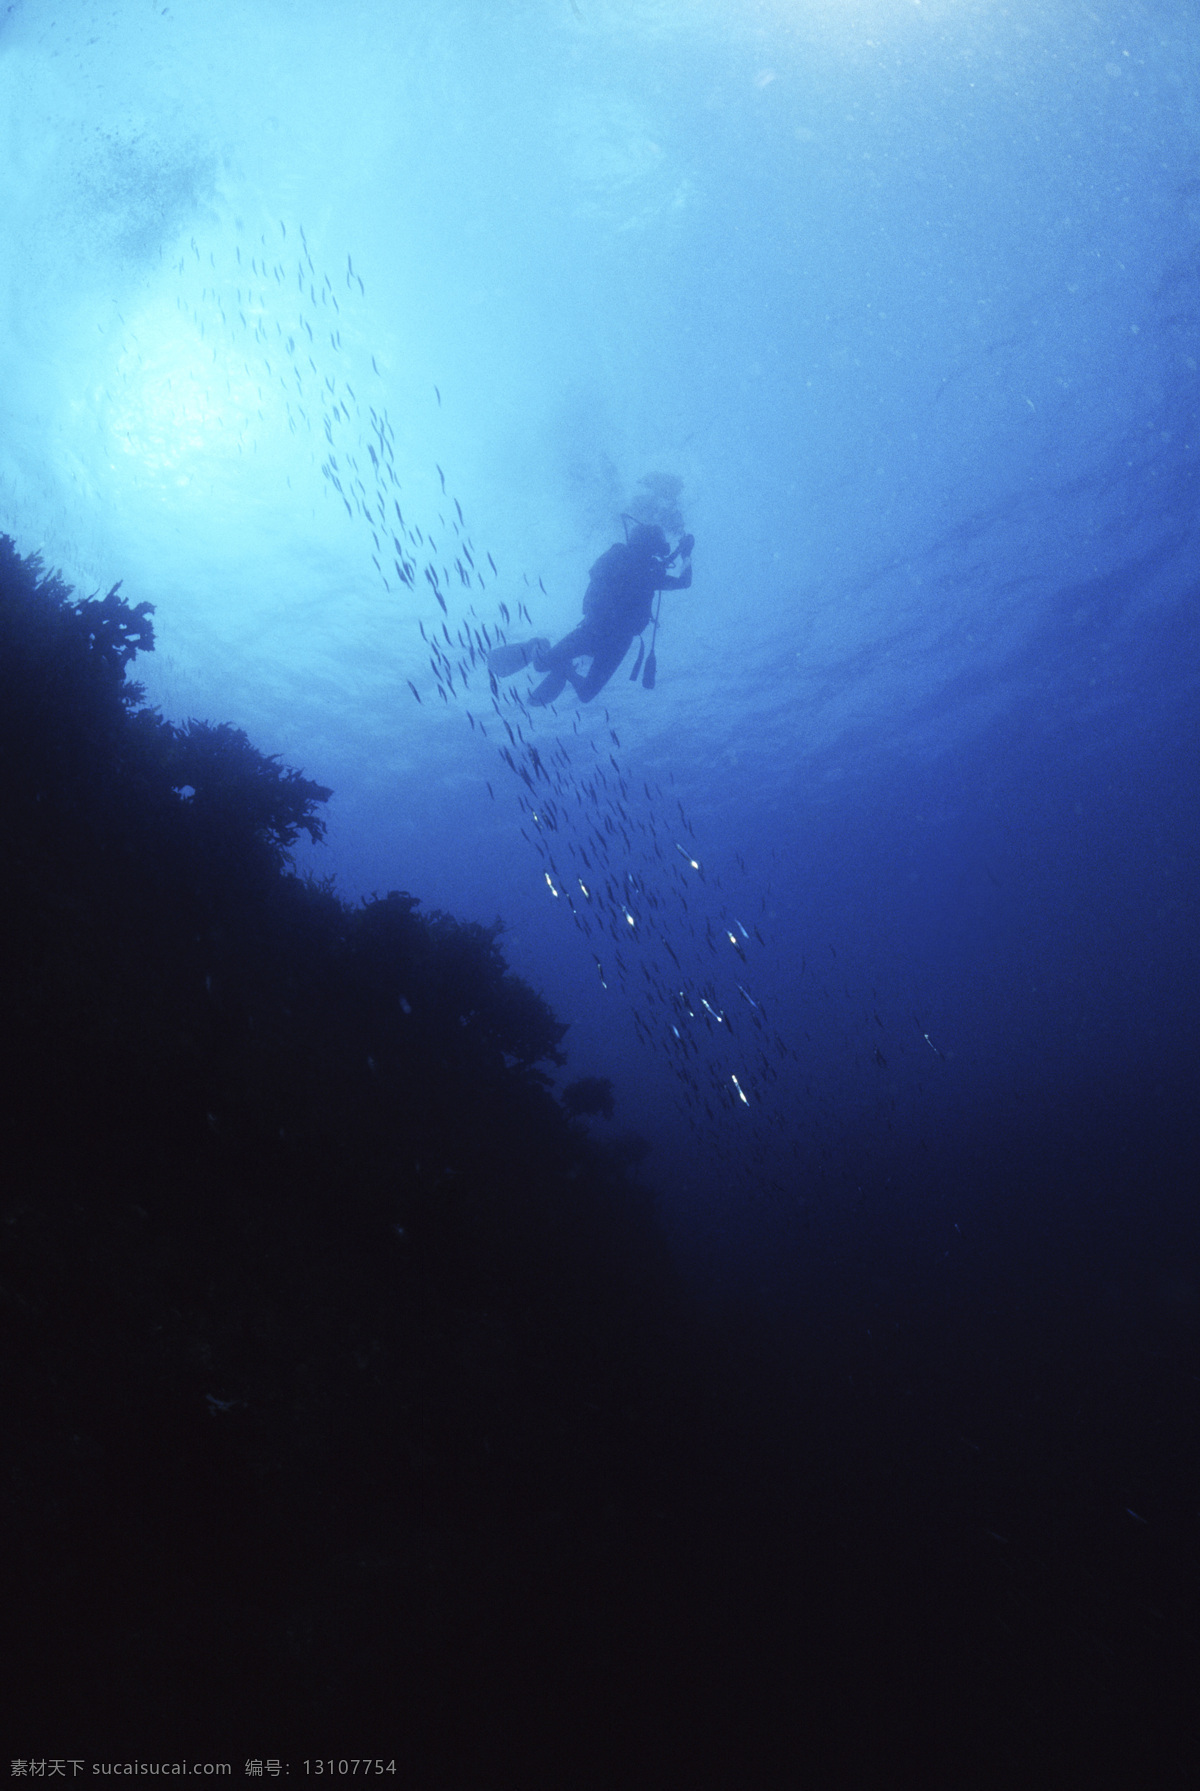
[{"x1": 0, "y1": 0, "x2": 1200, "y2": 1289}]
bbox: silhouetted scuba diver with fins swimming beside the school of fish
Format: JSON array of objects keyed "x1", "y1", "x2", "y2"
[{"x1": 487, "y1": 523, "x2": 695, "y2": 707}]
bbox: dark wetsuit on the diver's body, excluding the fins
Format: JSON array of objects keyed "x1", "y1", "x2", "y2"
[{"x1": 530, "y1": 541, "x2": 691, "y2": 704}]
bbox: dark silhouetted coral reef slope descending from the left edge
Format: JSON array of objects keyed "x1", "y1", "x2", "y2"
[{"x1": 0, "y1": 537, "x2": 723, "y2": 1784}]
